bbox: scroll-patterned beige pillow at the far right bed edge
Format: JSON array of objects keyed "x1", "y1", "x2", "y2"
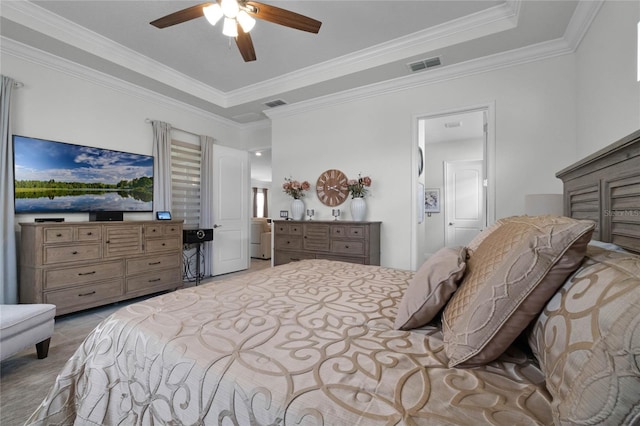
[{"x1": 529, "y1": 247, "x2": 640, "y2": 426}]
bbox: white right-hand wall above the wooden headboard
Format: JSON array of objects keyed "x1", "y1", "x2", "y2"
[{"x1": 567, "y1": 1, "x2": 640, "y2": 156}]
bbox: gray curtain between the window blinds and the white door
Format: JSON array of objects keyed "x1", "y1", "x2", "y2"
[{"x1": 200, "y1": 135, "x2": 215, "y2": 277}]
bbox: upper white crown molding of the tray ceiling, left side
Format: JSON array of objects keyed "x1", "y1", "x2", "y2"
[{"x1": 2, "y1": 1, "x2": 227, "y2": 107}]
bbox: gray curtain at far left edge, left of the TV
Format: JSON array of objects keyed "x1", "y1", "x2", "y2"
[{"x1": 0, "y1": 76, "x2": 18, "y2": 304}]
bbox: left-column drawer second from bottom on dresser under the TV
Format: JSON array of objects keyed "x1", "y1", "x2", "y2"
[{"x1": 44, "y1": 260, "x2": 124, "y2": 290}]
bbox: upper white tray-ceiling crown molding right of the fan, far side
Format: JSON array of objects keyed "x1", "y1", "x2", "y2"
[{"x1": 227, "y1": 0, "x2": 522, "y2": 106}]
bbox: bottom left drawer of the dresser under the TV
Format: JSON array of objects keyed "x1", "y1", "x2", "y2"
[{"x1": 44, "y1": 278, "x2": 123, "y2": 313}]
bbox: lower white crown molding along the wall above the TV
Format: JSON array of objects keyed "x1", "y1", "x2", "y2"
[{"x1": 0, "y1": 36, "x2": 250, "y2": 130}]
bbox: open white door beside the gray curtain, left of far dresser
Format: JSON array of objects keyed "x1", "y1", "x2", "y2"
[{"x1": 212, "y1": 145, "x2": 251, "y2": 275}]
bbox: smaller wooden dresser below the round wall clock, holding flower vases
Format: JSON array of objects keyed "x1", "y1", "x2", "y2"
[{"x1": 273, "y1": 220, "x2": 380, "y2": 265}]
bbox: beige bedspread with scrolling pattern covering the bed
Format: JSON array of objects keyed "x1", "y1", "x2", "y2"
[{"x1": 27, "y1": 260, "x2": 552, "y2": 426}]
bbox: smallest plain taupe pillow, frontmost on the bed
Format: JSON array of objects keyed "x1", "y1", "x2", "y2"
[{"x1": 394, "y1": 247, "x2": 467, "y2": 330}]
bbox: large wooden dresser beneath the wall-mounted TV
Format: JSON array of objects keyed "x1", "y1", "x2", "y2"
[{"x1": 20, "y1": 221, "x2": 182, "y2": 315}]
